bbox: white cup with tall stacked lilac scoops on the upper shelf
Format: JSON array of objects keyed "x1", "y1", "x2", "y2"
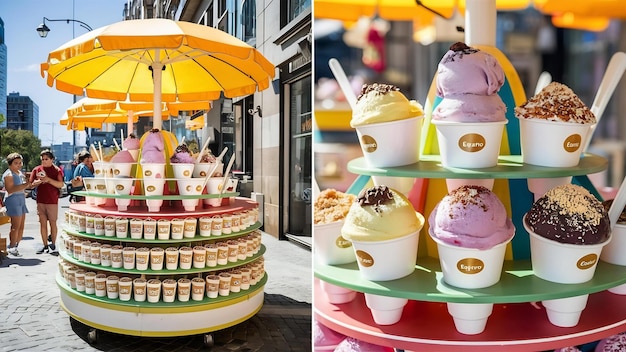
[{"x1": 432, "y1": 42, "x2": 507, "y2": 168}]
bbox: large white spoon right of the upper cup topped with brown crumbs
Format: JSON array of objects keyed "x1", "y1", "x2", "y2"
[{"x1": 583, "y1": 51, "x2": 626, "y2": 151}]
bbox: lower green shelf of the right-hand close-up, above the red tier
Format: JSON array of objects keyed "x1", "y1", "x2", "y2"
[{"x1": 314, "y1": 257, "x2": 626, "y2": 303}]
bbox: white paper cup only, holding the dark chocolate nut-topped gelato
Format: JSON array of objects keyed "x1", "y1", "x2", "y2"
[{"x1": 522, "y1": 219, "x2": 612, "y2": 284}]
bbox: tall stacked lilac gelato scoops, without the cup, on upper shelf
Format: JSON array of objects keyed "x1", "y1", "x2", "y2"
[{"x1": 432, "y1": 42, "x2": 506, "y2": 122}]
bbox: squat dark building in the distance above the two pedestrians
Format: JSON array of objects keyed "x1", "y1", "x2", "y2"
[{"x1": 6, "y1": 92, "x2": 39, "y2": 136}]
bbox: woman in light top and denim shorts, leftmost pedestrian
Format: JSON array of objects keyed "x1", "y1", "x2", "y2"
[{"x1": 2, "y1": 153, "x2": 41, "y2": 257}]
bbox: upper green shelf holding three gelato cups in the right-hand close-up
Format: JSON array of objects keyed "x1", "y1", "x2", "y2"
[{"x1": 348, "y1": 153, "x2": 608, "y2": 179}]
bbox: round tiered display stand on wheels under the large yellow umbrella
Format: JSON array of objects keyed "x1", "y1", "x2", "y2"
[{"x1": 57, "y1": 192, "x2": 267, "y2": 345}]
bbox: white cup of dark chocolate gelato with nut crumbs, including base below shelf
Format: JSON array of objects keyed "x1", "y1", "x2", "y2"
[{"x1": 524, "y1": 185, "x2": 611, "y2": 327}]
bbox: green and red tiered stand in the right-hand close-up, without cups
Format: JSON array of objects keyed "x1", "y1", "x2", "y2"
[{"x1": 314, "y1": 154, "x2": 626, "y2": 351}]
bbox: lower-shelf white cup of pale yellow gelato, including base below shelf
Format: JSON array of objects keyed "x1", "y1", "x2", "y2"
[{"x1": 341, "y1": 186, "x2": 424, "y2": 325}]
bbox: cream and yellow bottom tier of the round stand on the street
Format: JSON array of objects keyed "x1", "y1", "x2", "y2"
[{"x1": 56, "y1": 274, "x2": 267, "y2": 338}]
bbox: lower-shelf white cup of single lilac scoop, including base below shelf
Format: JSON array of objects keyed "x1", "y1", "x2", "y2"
[{"x1": 428, "y1": 185, "x2": 515, "y2": 335}]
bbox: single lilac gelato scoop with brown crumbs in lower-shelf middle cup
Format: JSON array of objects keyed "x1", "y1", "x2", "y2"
[{"x1": 428, "y1": 185, "x2": 515, "y2": 249}]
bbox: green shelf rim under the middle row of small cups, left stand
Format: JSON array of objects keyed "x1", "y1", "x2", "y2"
[{"x1": 59, "y1": 244, "x2": 266, "y2": 276}]
